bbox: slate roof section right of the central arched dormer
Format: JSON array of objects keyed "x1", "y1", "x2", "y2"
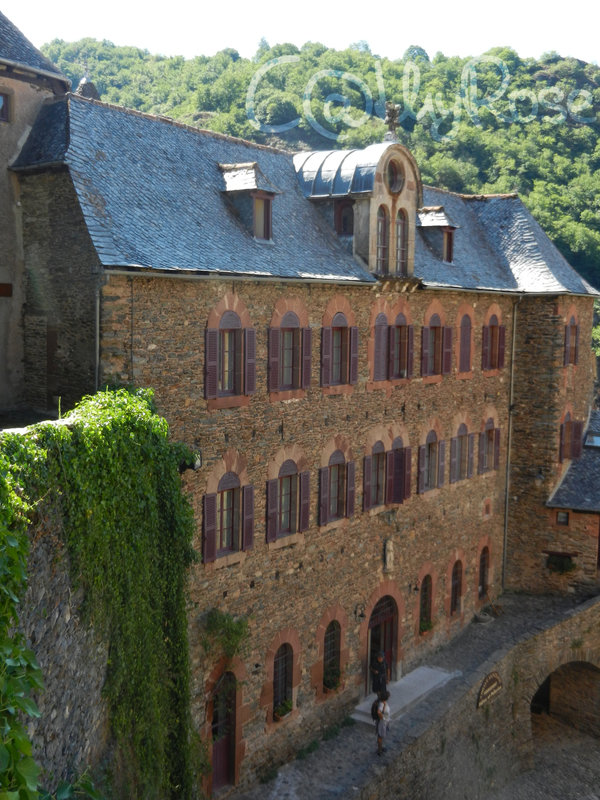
[{"x1": 415, "y1": 186, "x2": 600, "y2": 295}]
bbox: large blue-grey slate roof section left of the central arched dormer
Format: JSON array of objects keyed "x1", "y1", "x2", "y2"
[{"x1": 13, "y1": 95, "x2": 374, "y2": 283}]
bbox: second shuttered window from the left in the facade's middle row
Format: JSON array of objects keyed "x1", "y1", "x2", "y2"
[{"x1": 267, "y1": 459, "x2": 310, "y2": 542}]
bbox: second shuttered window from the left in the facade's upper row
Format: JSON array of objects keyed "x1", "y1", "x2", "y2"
[{"x1": 269, "y1": 311, "x2": 312, "y2": 392}]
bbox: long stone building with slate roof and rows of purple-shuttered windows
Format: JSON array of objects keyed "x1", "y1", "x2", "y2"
[{"x1": 0, "y1": 12, "x2": 599, "y2": 789}]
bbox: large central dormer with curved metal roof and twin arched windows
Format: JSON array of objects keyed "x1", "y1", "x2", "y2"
[{"x1": 294, "y1": 142, "x2": 422, "y2": 277}]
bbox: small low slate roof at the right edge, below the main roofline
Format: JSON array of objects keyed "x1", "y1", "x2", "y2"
[{"x1": 546, "y1": 411, "x2": 600, "y2": 512}]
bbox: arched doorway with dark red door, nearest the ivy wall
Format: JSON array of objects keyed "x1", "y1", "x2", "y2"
[{"x1": 211, "y1": 672, "x2": 236, "y2": 791}]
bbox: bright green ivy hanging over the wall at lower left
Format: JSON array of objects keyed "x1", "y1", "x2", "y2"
[{"x1": 0, "y1": 389, "x2": 194, "y2": 800}]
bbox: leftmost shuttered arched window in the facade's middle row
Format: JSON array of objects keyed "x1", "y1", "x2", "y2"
[{"x1": 202, "y1": 472, "x2": 254, "y2": 563}]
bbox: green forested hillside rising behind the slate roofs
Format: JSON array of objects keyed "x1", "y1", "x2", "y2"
[{"x1": 43, "y1": 39, "x2": 600, "y2": 288}]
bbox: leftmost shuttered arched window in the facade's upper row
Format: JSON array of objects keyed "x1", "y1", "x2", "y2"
[{"x1": 204, "y1": 311, "x2": 256, "y2": 400}]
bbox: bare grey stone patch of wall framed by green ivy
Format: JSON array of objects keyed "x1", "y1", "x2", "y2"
[{"x1": 20, "y1": 527, "x2": 108, "y2": 787}]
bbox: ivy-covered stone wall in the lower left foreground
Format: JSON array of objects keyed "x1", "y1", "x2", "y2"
[{"x1": 0, "y1": 390, "x2": 194, "y2": 800}]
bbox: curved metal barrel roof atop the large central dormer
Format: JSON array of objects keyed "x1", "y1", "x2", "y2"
[{"x1": 294, "y1": 142, "x2": 421, "y2": 203}]
